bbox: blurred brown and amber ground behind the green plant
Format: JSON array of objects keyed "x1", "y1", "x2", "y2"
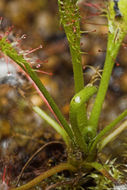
[{"x1": 0, "y1": 0, "x2": 127, "y2": 187}]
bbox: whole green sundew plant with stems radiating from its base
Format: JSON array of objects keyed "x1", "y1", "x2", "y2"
[{"x1": 0, "y1": 0, "x2": 127, "y2": 190}]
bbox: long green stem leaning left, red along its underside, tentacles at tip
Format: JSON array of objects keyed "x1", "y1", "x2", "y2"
[{"x1": 0, "y1": 38, "x2": 73, "y2": 140}]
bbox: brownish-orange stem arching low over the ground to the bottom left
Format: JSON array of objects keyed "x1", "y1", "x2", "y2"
[{"x1": 10, "y1": 163, "x2": 76, "y2": 190}]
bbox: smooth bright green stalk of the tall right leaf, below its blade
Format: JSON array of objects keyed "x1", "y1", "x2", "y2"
[{"x1": 89, "y1": 28, "x2": 124, "y2": 136}]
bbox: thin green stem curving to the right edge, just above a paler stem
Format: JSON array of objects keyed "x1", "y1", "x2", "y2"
[{"x1": 88, "y1": 110, "x2": 127, "y2": 160}]
